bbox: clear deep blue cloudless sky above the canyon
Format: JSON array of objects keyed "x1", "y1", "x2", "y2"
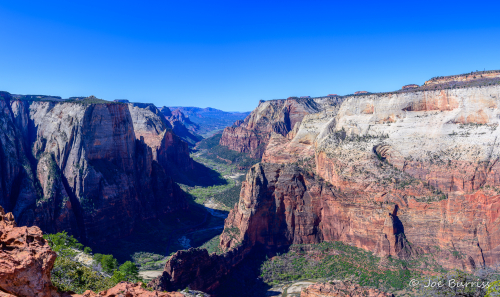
[{"x1": 0, "y1": 0, "x2": 500, "y2": 111}]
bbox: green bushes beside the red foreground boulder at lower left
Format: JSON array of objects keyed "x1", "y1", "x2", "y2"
[{"x1": 44, "y1": 231, "x2": 142, "y2": 294}]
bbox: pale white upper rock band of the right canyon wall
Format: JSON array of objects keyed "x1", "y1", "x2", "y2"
[{"x1": 263, "y1": 85, "x2": 500, "y2": 192}]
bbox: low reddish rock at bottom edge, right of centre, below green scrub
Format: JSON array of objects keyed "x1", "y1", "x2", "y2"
[{"x1": 300, "y1": 281, "x2": 394, "y2": 297}]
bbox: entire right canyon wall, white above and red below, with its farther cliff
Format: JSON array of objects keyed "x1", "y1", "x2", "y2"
[{"x1": 151, "y1": 74, "x2": 500, "y2": 291}]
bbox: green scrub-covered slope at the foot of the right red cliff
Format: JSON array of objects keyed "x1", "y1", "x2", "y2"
[{"x1": 260, "y1": 241, "x2": 441, "y2": 291}]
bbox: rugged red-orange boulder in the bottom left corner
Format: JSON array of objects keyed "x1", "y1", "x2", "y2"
[{"x1": 0, "y1": 207, "x2": 57, "y2": 297}]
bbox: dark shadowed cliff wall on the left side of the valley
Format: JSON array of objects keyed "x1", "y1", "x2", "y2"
[{"x1": 0, "y1": 93, "x2": 190, "y2": 242}]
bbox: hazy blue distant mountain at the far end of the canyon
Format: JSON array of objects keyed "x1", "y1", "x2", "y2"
[{"x1": 169, "y1": 106, "x2": 250, "y2": 137}]
